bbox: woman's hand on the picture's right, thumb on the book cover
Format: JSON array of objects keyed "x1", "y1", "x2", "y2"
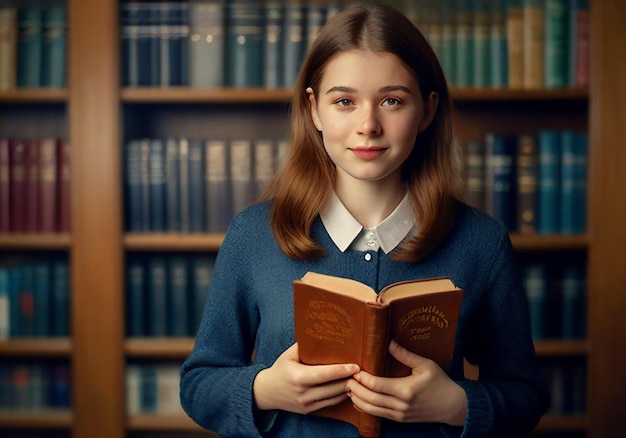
[{"x1": 348, "y1": 341, "x2": 467, "y2": 426}]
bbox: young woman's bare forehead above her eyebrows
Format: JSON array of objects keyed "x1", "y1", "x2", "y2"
[{"x1": 322, "y1": 49, "x2": 417, "y2": 88}]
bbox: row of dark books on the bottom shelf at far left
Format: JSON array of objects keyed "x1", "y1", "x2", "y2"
[{"x1": 0, "y1": 360, "x2": 71, "y2": 412}]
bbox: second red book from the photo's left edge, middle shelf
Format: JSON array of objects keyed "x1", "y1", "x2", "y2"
[{"x1": 9, "y1": 140, "x2": 26, "y2": 233}]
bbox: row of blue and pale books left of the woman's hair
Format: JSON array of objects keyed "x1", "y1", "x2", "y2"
[{"x1": 124, "y1": 138, "x2": 288, "y2": 233}]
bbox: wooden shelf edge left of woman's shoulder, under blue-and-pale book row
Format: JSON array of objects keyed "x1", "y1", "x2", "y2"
[{"x1": 123, "y1": 233, "x2": 224, "y2": 251}]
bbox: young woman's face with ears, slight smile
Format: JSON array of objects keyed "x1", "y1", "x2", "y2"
[{"x1": 307, "y1": 50, "x2": 437, "y2": 188}]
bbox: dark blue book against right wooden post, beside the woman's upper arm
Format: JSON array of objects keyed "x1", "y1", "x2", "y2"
[{"x1": 561, "y1": 266, "x2": 587, "y2": 339}]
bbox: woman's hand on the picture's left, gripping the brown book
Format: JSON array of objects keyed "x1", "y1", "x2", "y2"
[{"x1": 254, "y1": 343, "x2": 359, "y2": 414}]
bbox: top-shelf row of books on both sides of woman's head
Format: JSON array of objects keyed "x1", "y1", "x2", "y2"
[{"x1": 120, "y1": 0, "x2": 589, "y2": 89}]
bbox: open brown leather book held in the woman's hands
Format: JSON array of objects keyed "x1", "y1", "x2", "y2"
[{"x1": 293, "y1": 272, "x2": 463, "y2": 437}]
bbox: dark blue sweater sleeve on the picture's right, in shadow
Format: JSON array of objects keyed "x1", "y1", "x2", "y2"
[{"x1": 450, "y1": 233, "x2": 549, "y2": 438}]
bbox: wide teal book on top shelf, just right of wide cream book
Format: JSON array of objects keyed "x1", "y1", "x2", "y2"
[{"x1": 226, "y1": 0, "x2": 264, "y2": 88}]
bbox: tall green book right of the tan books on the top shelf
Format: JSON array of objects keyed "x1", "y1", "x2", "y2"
[{"x1": 543, "y1": 0, "x2": 570, "y2": 88}]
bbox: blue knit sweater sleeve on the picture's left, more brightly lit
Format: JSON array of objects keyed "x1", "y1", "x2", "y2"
[{"x1": 180, "y1": 215, "x2": 265, "y2": 438}]
